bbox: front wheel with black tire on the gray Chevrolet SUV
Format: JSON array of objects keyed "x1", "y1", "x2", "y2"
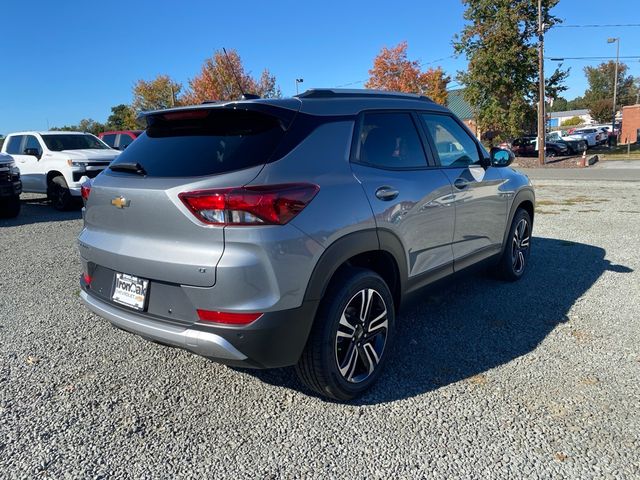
[{"x1": 497, "y1": 208, "x2": 533, "y2": 282}]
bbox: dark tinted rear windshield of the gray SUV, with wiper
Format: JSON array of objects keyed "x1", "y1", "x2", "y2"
[{"x1": 111, "y1": 109, "x2": 285, "y2": 177}]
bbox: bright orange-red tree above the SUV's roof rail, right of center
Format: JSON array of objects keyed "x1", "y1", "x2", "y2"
[{"x1": 365, "y1": 41, "x2": 451, "y2": 105}]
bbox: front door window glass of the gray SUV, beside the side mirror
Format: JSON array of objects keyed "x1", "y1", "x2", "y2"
[{"x1": 420, "y1": 113, "x2": 480, "y2": 167}]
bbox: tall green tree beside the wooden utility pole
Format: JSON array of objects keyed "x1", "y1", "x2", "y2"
[{"x1": 453, "y1": 0, "x2": 568, "y2": 139}]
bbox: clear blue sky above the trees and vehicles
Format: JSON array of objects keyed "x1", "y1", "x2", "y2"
[{"x1": 0, "y1": 0, "x2": 640, "y2": 134}]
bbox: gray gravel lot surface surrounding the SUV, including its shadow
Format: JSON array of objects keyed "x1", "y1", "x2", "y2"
[{"x1": 0, "y1": 188, "x2": 640, "y2": 479}]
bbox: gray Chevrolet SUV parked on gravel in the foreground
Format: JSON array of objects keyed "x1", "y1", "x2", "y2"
[{"x1": 79, "y1": 90, "x2": 534, "y2": 400}]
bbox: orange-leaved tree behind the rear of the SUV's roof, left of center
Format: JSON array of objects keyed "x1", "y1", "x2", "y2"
[{"x1": 180, "y1": 50, "x2": 282, "y2": 104}]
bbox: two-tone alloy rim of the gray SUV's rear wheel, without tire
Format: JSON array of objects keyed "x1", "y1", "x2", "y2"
[{"x1": 335, "y1": 288, "x2": 389, "y2": 383}]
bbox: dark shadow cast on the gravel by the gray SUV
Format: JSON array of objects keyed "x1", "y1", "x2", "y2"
[{"x1": 243, "y1": 237, "x2": 632, "y2": 405}]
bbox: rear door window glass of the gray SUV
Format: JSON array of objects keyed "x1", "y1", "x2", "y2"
[{"x1": 358, "y1": 113, "x2": 427, "y2": 168}]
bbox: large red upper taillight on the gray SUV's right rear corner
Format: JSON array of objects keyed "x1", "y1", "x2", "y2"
[{"x1": 178, "y1": 183, "x2": 320, "y2": 225}]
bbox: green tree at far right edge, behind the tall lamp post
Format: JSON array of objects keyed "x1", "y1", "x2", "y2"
[{"x1": 584, "y1": 60, "x2": 637, "y2": 107}]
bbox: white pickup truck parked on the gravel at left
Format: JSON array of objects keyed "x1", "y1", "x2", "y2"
[{"x1": 2, "y1": 132, "x2": 120, "y2": 210}]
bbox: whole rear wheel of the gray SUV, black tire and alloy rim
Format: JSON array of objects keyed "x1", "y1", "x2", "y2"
[{"x1": 296, "y1": 267, "x2": 395, "y2": 401}]
